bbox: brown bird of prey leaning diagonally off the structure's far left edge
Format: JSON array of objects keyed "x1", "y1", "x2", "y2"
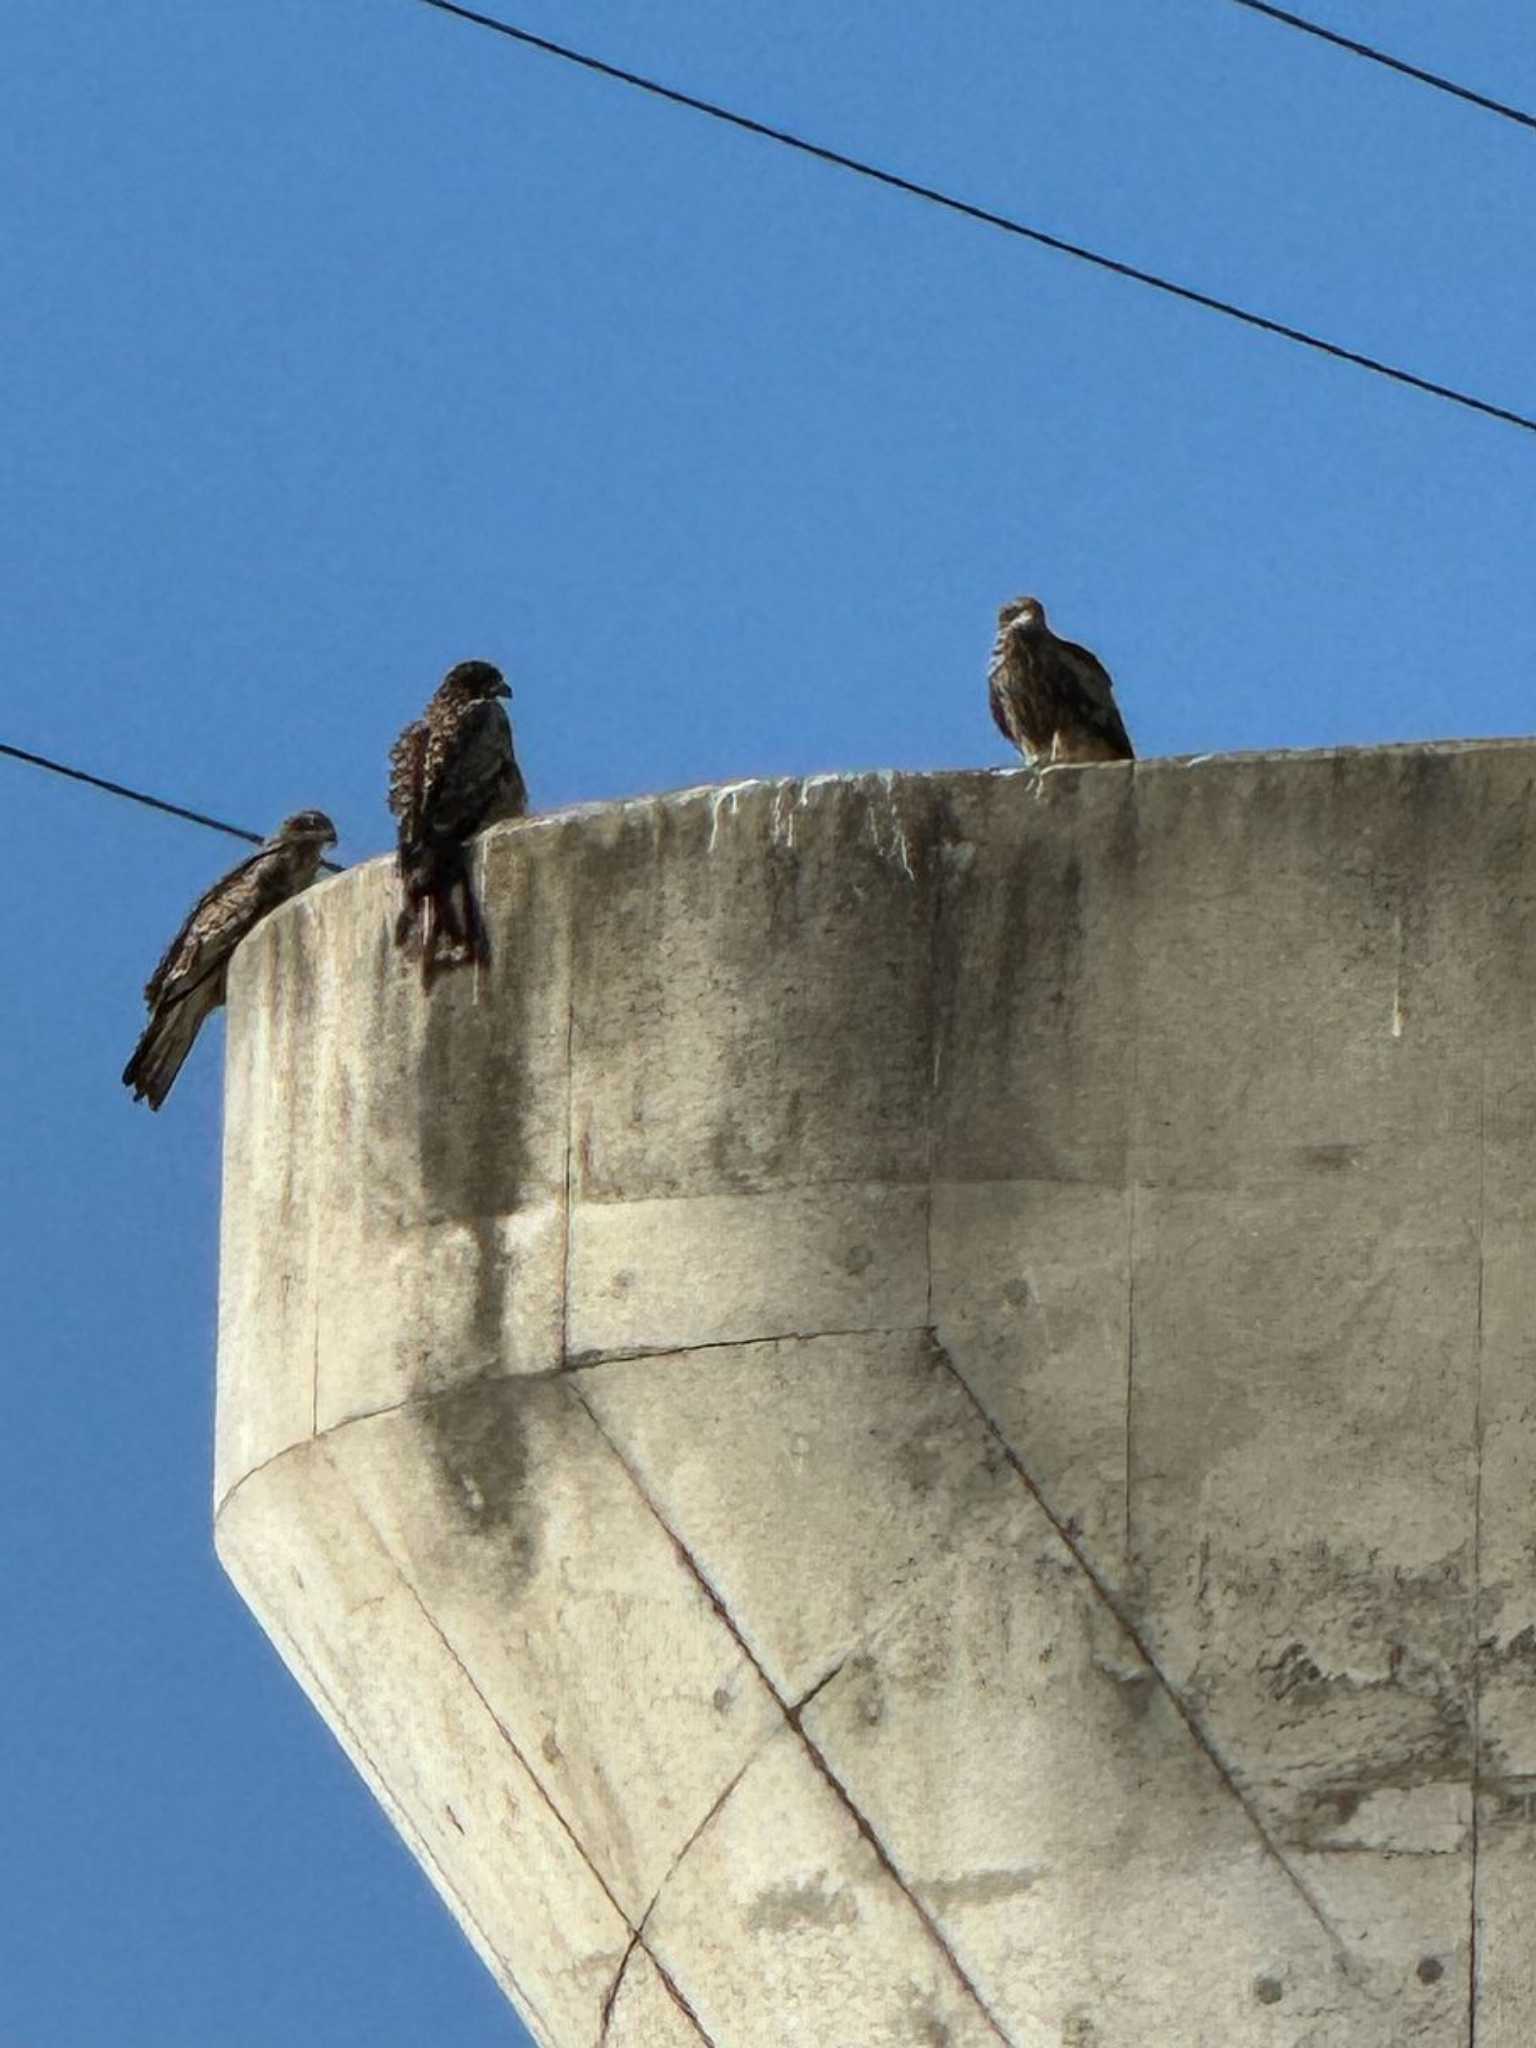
[{"x1": 123, "y1": 811, "x2": 336, "y2": 1110}]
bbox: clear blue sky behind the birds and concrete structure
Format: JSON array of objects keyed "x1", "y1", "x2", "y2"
[{"x1": 0, "y1": 0, "x2": 1536, "y2": 2048}]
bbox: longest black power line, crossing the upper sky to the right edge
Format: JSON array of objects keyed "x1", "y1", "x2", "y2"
[{"x1": 405, "y1": 0, "x2": 1536, "y2": 434}]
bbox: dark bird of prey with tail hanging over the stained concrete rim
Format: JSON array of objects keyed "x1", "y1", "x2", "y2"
[{"x1": 389, "y1": 662, "x2": 528, "y2": 987}]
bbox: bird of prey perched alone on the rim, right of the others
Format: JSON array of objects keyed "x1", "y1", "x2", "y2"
[{"x1": 987, "y1": 598, "x2": 1137, "y2": 764}]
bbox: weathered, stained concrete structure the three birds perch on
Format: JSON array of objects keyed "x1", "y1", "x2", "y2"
[{"x1": 217, "y1": 743, "x2": 1536, "y2": 2048}]
